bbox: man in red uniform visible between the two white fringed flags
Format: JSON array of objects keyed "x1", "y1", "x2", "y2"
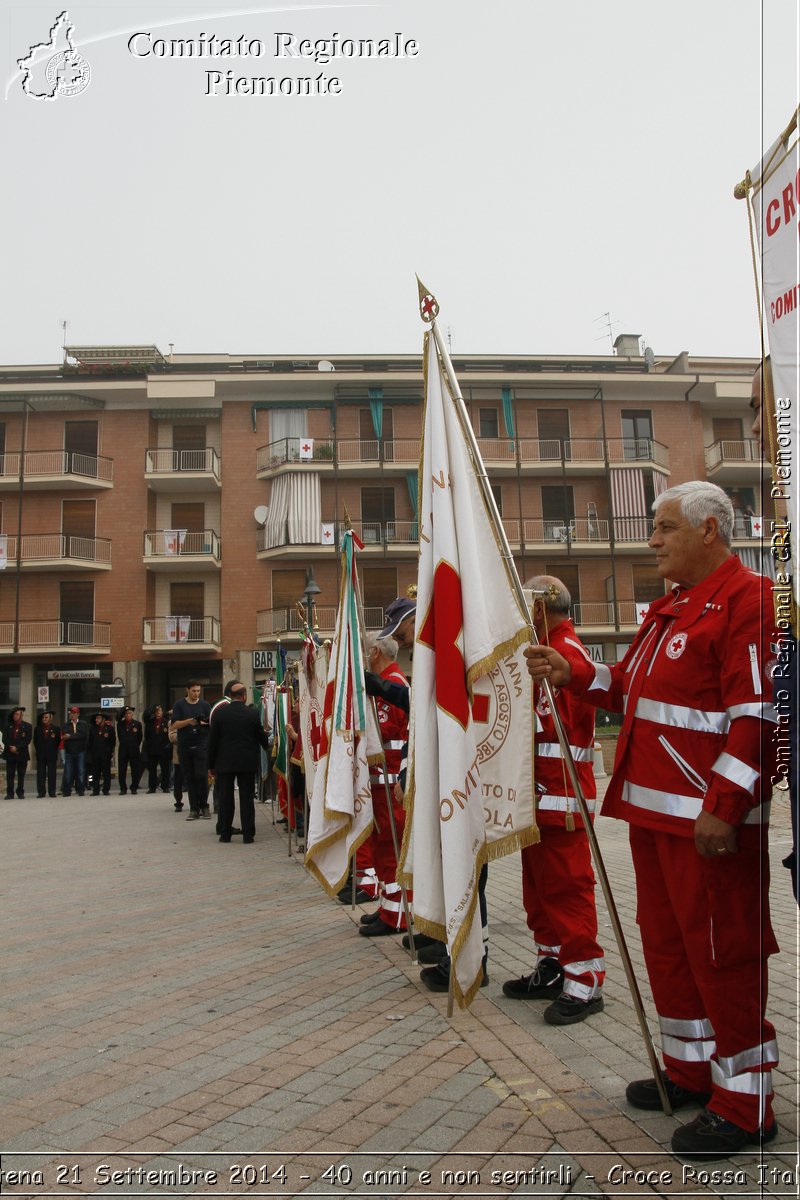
[{"x1": 359, "y1": 634, "x2": 410, "y2": 937}]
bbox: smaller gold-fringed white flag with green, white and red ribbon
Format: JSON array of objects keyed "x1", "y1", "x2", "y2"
[{"x1": 306, "y1": 529, "x2": 383, "y2": 895}]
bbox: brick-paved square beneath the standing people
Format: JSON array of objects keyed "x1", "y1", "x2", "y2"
[{"x1": 0, "y1": 796, "x2": 798, "y2": 1198}]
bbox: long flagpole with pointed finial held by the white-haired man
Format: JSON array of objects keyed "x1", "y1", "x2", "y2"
[{"x1": 416, "y1": 275, "x2": 672, "y2": 1116}]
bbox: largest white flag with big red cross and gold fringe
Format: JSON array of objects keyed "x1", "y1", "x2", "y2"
[{"x1": 399, "y1": 332, "x2": 539, "y2": 1006}]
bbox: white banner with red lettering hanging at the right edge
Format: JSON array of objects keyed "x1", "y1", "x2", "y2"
[{"x1": 751, "y1": 130, "x2": 800, "y2": 609}]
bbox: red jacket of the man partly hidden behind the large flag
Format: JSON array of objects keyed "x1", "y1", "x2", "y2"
[{"x1": 534, "y1": 619, "x2": 597, "y2": 829}]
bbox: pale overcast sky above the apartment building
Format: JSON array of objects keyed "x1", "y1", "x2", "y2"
[{"x1": 0, "y1": 0, "x2": 799, "y2": 364}]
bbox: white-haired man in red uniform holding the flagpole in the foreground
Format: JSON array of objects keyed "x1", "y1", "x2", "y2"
[{"x1": 525, "y1": 481, "x2": 777, "y2": 1159}]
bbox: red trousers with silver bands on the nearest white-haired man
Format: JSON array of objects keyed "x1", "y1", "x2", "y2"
[{"x1": 631, "y1": 826, "x2": 777, "y2": 1132}]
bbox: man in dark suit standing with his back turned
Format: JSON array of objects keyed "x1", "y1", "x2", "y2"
[{"x1": 209, "y1": 680, "x2": 269, "y2": 844}]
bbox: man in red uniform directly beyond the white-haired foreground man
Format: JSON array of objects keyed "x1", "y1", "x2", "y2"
[{"x1": 503, "y1": 575, "x2": 606, "y2": 1025}]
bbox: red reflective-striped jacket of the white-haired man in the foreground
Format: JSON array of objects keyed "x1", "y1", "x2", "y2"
[{"x1": 570, "y1": 556, "x2": 776, "y2": 838}]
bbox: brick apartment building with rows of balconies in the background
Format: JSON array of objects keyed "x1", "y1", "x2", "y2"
[{"x1": 0, "y1": 336, "x2": 769, "y2": 714}]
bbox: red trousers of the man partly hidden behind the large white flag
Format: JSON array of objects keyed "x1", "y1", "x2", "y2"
[{"x1": 522, "y1": 824, "x2": 606, "y2": 1000}]
